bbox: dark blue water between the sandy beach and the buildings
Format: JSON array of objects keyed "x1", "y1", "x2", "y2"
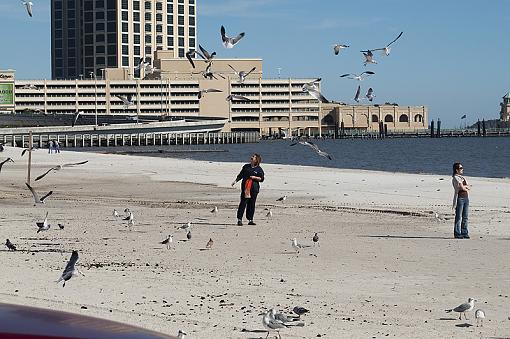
[{"x1": 86, "y1": 137, "x2": 510, "y2": 178}]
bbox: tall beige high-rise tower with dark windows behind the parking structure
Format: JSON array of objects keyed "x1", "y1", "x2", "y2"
[{"x1": 51, "y1": 0, "x2": 197, "y2": 79}]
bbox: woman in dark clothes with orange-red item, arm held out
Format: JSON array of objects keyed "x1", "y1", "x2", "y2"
[{"x1": 232, "y1": 153, "x2": 264, "y2": 226}]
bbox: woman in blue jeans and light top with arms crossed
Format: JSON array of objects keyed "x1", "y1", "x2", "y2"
[{"x1": 452, "y1": 162, "x2": 469, "y2": 239}]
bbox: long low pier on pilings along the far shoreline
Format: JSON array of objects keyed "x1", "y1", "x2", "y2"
[{"x1": 0, "y1": 132, "x2": 260, "y2": 148}]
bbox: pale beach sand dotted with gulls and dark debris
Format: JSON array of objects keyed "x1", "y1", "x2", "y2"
[{"x1": 0, "y1": 147, "x2": 510, "y2": 338}]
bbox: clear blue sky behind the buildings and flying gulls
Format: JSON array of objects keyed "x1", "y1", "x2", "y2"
[{"x1": 0, "y1": 0, "x2": 510, "y2": 127}]
